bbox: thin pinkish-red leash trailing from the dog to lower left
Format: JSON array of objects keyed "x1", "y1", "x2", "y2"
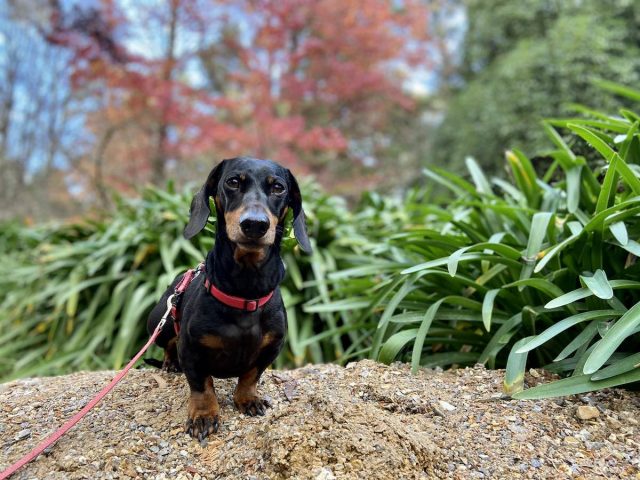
[{"x1": 0, "y1": 295, "x2": 173, "y2": 480}]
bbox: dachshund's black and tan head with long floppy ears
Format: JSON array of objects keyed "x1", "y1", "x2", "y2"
[{"x1": 184, "y1": 157, "x2": 311, "y2": 259}]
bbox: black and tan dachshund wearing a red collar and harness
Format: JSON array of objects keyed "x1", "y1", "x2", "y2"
[{"x1": 147, "y1": 157, "x2": 311, "y2": 439}]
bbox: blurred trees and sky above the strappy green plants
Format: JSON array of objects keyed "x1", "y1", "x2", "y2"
[{"x1": 0, "y1": 0, "x2": 640, "y2": 220}]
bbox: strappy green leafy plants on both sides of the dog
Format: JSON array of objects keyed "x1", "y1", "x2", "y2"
[{"x1": 0, "y1": 82, "x2": 640, "y2": 398}]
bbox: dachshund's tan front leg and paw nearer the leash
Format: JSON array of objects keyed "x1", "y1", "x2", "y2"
[{"x1": 186, "y1": 375, "x2": 220, "y2": 440}]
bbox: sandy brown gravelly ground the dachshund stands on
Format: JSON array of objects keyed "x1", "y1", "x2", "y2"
[{"x1": 0, "y1": 361, "x2": 640, "y2": 480}]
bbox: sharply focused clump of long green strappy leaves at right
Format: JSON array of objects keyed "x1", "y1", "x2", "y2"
[{"x1": 314, "y1": 83, "x2": 640, "y2": 398}]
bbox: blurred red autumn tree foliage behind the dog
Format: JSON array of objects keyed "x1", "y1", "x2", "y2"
[{"x1": 33, "y1": 0, "x2": 428, "y2": 193}]
